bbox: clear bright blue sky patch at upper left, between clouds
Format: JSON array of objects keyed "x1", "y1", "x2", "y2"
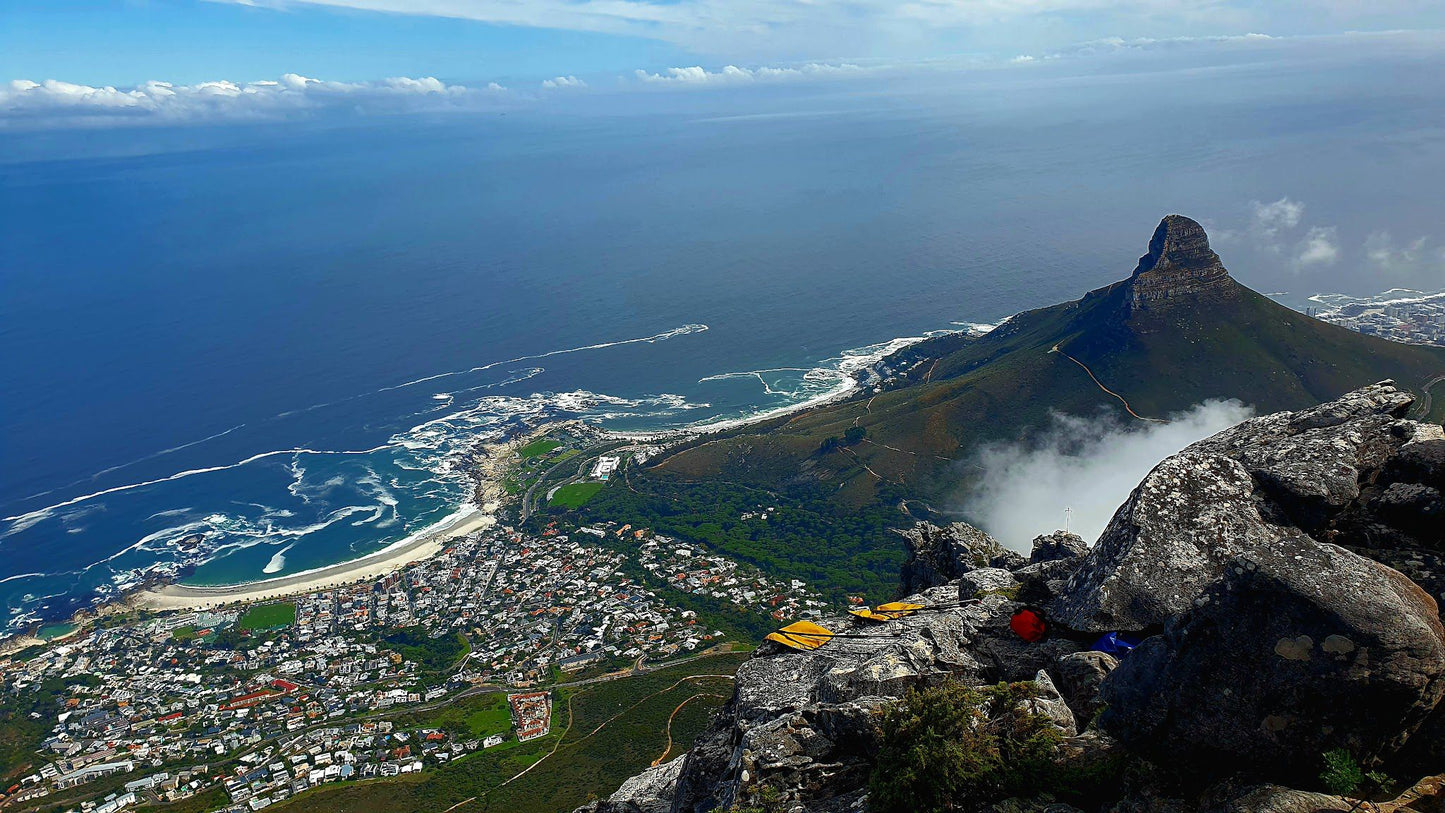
[{"x1": 0, "y1": 0, "x2": 683, "y2": 87}]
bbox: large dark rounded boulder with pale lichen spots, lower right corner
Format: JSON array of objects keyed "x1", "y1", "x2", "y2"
[{"x1": 1100, "y1": 537, "x2": 1445, "y2": 781}]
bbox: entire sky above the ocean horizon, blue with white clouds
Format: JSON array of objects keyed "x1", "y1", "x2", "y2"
[{"x1": 8, "y1": 0, "x2": 1445, "y2": 124}]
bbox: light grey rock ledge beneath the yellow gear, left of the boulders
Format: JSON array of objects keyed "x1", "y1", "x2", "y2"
[{"x1": 673, "y1": 586, "x2": 1077, "y2": 813}]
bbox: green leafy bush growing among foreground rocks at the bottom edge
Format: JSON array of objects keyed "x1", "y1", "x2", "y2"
[{"x1": 868, "y1": 682, "x2": 1062, "y2": 813}]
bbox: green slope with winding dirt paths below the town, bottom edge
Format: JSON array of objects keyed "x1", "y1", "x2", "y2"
[{"x1": 265, "y1": 654, "x2": 747, "y2": 813}]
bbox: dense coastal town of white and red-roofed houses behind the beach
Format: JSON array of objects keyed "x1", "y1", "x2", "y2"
[{"x1": 0, "y1": 436, "x2": 828, "y2": 813}]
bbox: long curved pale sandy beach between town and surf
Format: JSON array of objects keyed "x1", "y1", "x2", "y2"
[{"x1": 129, "y1": 504, "x2": 497, "y2": 609}]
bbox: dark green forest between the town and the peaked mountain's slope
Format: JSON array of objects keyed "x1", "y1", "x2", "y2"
[{"x1": 557, "y1": 468, "x2": 907, "y2": 601}]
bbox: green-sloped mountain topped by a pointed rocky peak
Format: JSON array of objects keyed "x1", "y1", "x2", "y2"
[{"x1": 655, "y1": 215, "x2": 1445, "y2": 505}]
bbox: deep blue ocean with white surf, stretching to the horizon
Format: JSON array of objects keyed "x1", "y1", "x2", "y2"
[{"x1": 0, "y1": 54, "x2": 1445, "y2": 628}]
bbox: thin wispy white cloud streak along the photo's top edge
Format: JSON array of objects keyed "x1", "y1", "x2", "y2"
[{"x1": 203, "y1": 0, "x2": 1445, "y2": 61}]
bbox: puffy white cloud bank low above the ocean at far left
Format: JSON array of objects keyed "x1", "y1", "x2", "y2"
[{"x1": 0, "y1": 74, "x2": 506, "y2": 127}]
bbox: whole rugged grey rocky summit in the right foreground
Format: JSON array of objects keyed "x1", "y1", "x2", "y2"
[{"x1": 581, "y1": 384, "x2": 1445, "y2": 813}]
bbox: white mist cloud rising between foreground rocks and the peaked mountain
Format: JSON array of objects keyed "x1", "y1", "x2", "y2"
[{"x1": 964, "y1": 401, "x2": 1253, "y2": 552}]
